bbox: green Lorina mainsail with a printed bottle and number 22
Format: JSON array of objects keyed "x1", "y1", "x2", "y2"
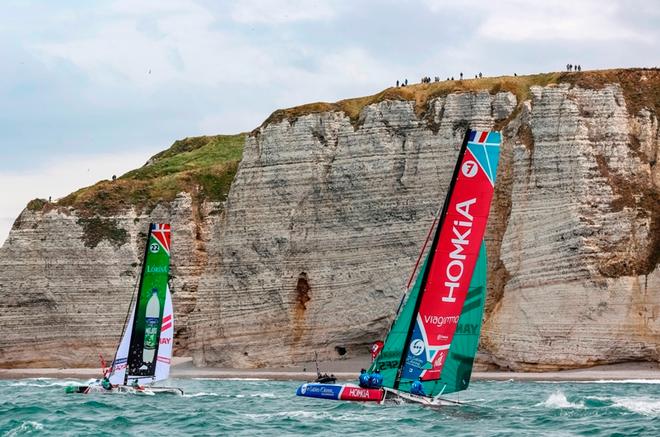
[{"x1": 128, "y1": 223, "x2": 170, "y2": 377}]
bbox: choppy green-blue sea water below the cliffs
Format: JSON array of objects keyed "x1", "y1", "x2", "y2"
[{"x1": 0, "y1": 379, "x2": 660, "y2": 436}]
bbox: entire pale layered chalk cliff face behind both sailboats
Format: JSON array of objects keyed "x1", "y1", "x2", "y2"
[{"x1": 0, "y1": 70, "x2": 660, "y2": 369}]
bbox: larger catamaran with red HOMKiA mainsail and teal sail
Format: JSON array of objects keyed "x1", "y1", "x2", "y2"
[{"x1": 296, "y1": 130, "x2": 502, "y2": 405}]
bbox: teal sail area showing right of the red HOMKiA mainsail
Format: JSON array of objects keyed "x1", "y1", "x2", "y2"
[{"x1": 399, "y1": 242, "x2": 487, "y2": 396}]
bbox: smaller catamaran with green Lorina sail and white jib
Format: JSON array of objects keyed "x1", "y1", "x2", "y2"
[{"x1": 66, "y1": 223, "x2": 183, "y2": 394}]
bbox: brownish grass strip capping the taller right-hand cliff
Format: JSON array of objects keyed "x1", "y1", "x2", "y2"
[{"x1": 262, "y1": 68, "x2": 660, "y2": 126}]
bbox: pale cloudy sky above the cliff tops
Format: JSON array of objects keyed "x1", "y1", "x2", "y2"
[{"x1": 0, "y1": 0, "x2": 660, "y2": 242}]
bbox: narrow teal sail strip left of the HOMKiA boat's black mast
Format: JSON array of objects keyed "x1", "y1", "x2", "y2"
[{"x1": 369, "y1": 255, "x2": 430, "y2": 388}]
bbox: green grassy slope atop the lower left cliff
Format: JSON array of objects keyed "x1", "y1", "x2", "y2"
[{"x1": 57, "y1": 134, "x2": 245, "y2": 217}]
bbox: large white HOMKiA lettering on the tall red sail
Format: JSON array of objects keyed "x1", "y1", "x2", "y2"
[{"x1": 442, "y1": 197, "x2": 477, "y2": 302}]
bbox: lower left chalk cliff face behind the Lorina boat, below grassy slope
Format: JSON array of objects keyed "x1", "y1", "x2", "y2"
[{"x1": 0, "y1": 194, "x2": 211, "y2": 367}]
